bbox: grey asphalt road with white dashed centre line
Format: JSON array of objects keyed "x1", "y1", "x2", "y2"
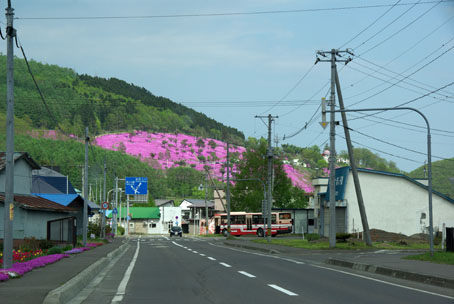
[{"x1": 77, "y1": 236, "x2": 454, "y2": 304}]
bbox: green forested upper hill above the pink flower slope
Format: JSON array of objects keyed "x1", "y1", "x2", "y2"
[{"x1": 0, "y1": 55, "x2": 244, "y2": 144}]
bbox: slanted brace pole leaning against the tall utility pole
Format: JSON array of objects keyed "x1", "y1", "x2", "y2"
[{"x1": 335, "y1": 63, "x2": 372, "y2": 246}]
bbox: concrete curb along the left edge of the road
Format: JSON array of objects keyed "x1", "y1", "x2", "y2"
[{"x1": 42, "y1": 243, "x2": 128, "y2": 304}]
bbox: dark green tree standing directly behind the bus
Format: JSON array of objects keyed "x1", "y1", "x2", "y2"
[{"x1": 231, "y1": 138, "x2": 307, "y2": 212}]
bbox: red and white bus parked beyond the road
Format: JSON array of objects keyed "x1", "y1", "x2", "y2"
[{"x1": 214, "y1": 212, "x2": 292, "y2": 237}]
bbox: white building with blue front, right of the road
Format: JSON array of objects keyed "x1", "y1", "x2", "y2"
[{"x1": 309, "y1": 167, "x2": 454, "y2": 236}]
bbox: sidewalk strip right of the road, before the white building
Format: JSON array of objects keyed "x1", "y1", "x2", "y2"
[{"x1": 223, "y1": 237, "x2": 454, "y2": 289}]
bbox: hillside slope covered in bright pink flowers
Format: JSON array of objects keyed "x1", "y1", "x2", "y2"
[{"x1": 95, "y1": 131, "x2": 314, "y2": 193}]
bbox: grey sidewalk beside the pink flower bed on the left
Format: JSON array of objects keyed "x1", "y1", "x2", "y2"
[{"x1": 0, "y1": 237, "x2": 125, "y2": 304}]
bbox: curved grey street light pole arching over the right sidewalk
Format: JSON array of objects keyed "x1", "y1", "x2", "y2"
[{"x1": 326, "y1": 107, "x2": 434, "y2": 256}]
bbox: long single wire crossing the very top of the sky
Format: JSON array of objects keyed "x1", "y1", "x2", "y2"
[{"x1": 14, "y1": 0, "x2": 453, "y2": 20}]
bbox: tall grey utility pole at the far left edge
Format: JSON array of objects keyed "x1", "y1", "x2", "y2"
[{"x1": 3, "y1": 0, "x2": 16, "y2": 269}]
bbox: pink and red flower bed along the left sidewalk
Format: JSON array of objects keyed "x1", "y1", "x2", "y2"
[{"x1": 0, "y1": 242, "x2": 104, "y2": 282}]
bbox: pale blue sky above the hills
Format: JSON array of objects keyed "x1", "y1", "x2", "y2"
[{"x1": 4, "y1": 0, "x2": 454, "y2": 174}]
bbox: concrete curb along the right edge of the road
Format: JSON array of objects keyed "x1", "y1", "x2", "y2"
[{"x1": 325, "y1": 259, "x2": 454, "y2": 289}]
